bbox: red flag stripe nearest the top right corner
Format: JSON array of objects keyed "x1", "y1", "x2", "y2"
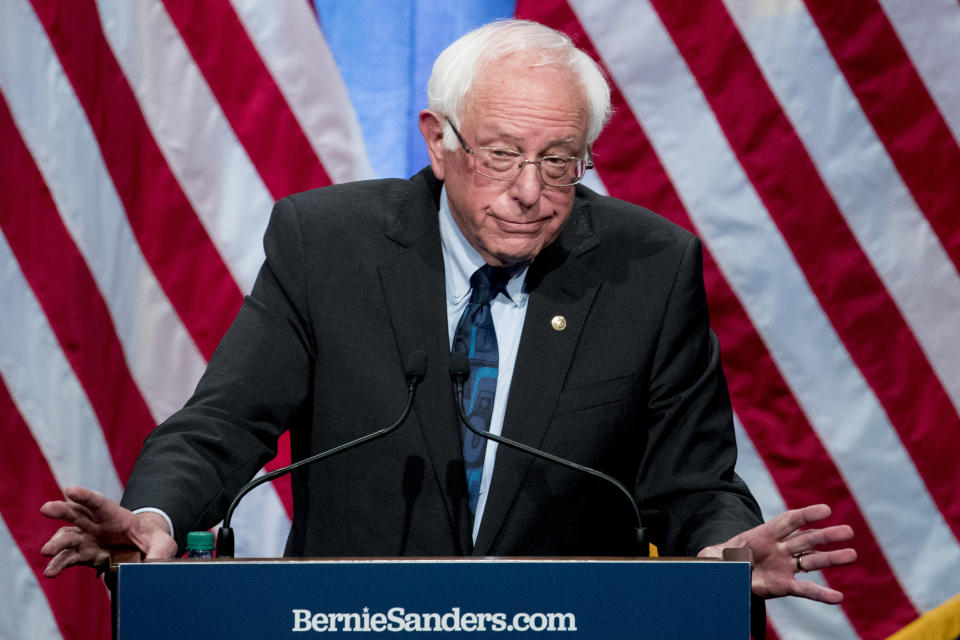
[{"x1": 806, "y1": 0, "x2": 960, "y2": 269}]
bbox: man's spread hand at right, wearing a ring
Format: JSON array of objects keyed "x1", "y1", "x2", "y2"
[{"x1": 697, "y1": 504, "x2": 857, "y2": 604}]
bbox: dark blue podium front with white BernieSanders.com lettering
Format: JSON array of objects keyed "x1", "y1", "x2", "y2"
[{"x1": 114, "y1": 556, "x2": 750, "y2": 640}]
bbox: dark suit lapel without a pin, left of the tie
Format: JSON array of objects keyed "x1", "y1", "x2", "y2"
[{"x1": 378, "y1": 173, "x2": 471, "y2": 553}]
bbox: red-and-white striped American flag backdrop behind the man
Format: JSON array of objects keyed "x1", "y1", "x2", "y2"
[{"x1": 0, "y1": 0, "x2": 960, "y2": 640}]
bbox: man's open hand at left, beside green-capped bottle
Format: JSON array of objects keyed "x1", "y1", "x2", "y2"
[{"x1": 40, "y1": 487, "x2": 177, "y2": 578}]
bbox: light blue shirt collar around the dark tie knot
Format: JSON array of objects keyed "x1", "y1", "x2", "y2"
[{"x1": 440, "y1": 186, "x2": 530, "y2": 306}]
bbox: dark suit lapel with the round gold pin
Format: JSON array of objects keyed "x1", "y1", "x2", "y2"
[{"x1": 474, "y1": 201, "x2": 600, "y2": 555}]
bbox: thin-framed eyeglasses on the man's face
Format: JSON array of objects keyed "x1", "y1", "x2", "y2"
[{"x1": 447, "y1": 120, "x2": 593, "y2": 187}]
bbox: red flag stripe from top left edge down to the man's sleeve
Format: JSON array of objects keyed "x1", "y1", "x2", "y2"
[{"x1": 32, "y1": 0, "x2": 242, "y2": 358}]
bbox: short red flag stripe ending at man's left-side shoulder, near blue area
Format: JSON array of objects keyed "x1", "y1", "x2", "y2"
[{"x1": 164, "y1": 0, "x2": 331, "y2": 199}]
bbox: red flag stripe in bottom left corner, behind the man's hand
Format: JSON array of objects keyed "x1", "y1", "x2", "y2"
[{"x1": 0, "y1": 376, "x2": 110, "y2": 640}]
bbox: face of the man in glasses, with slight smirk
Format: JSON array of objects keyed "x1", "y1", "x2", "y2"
[{"x1": 421, "y1": 56, "x2": 588, "y2": 266}]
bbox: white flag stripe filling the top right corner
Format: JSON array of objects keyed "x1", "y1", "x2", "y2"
[{"x1": 880, "y1": 0, "x2": 960, "y2": 144}]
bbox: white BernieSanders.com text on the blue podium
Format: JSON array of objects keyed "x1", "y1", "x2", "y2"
[{"x1": 291, "y1": 607, "x2": 577, "y2": 633}]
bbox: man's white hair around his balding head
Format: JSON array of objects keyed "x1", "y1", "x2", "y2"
[{"x1": 427, "y1": 20, "x2": 610, "y2": 150}]
